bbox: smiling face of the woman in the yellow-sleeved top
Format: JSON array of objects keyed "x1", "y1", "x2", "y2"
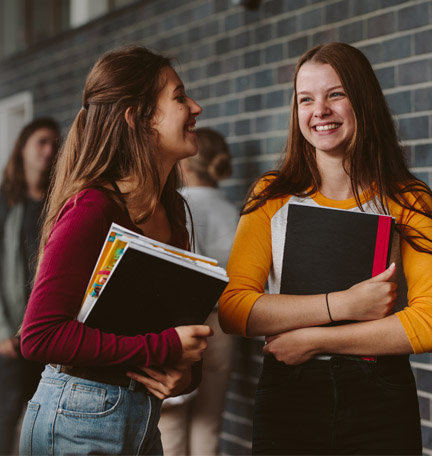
[{"x1": 297, "y1": 62, "x2": 355, "y2": 156}]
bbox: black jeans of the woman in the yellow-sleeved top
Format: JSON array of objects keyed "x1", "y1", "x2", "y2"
[{"x1": 252, "y1": 356, "x2": 422, "y2": 455}]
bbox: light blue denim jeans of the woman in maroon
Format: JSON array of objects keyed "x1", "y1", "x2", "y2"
[{"x1": 20, "y1": 365, "x2": 163, "y2": 456}]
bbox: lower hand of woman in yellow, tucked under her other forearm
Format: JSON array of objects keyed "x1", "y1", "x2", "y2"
[{"x1": 263, "y1": 328, "x2": 318, "y2": 364}]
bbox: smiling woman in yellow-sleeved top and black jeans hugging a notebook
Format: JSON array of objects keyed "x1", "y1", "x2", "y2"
[{"x1": 219, "y1": 43, "x2": 432, "y2": 455}]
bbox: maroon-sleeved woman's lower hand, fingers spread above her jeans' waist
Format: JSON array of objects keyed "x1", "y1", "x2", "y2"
[{"x1": 127, "y1": 367, "x2": 192, "y2": 400}]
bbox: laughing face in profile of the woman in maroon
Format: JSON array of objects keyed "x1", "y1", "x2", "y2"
[{"x1": 152, "y1": 68, "x2": 202, "y2": 165}]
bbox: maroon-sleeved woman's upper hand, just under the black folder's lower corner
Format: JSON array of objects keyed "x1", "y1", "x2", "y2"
[{"x1": 175, "y1": 325, "x2": 213, "y2": 368}]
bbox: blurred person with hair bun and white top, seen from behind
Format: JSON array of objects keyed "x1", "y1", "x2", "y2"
[{"x1": 159, "y1": 128, "x2": 239, "y2": 456}]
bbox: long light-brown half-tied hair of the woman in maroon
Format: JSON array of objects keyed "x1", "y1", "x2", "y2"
[{"x1": 39, "y1": 46, "x2": 188, "y2": 257}]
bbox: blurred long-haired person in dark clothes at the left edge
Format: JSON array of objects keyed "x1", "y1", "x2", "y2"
[{"x1": 0, "y1": 118, "x2": 60, "y2": 454}]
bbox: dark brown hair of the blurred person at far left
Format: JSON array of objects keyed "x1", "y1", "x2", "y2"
[{"x1": 0, "y1": 117, "x2": 60, "y2": 206}]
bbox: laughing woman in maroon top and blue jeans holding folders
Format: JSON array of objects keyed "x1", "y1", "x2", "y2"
[{"x1": 20, "y1": 46, "x2": 212, "y2": 454}]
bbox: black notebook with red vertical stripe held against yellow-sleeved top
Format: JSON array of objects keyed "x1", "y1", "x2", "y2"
[{"x1": 280, "y1": 203, "x2": 394, "y2": 324}]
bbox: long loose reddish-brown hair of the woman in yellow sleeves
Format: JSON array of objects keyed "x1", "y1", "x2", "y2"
[{"x1": 242, "y1": 43, "x2": 432, "y2": 253}]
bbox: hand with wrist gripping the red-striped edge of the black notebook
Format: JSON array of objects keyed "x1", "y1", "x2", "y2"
[{"x1": 328, "y1": 263, "x2": 397, "y2": 321}]
